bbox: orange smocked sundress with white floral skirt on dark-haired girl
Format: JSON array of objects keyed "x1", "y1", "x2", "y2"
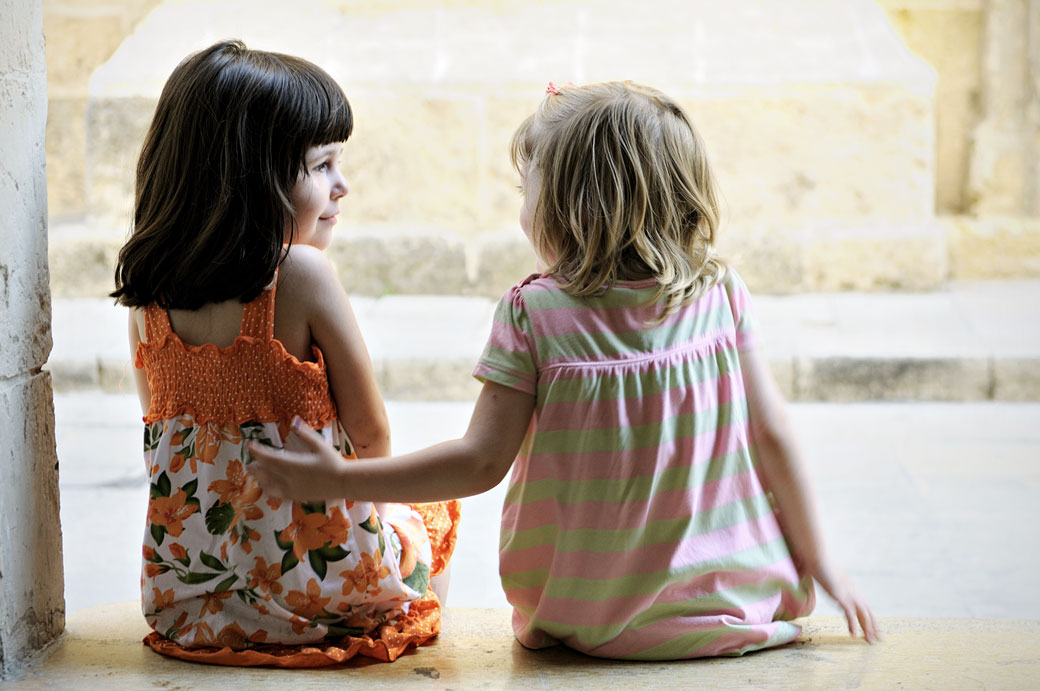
[{"x1": 135, "y1": 282, "x2": 459, "y2": 667}]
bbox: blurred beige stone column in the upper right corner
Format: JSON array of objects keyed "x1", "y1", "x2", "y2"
[{"x1": 968, "y1": 0, "x2": 1040, "y2": 215}]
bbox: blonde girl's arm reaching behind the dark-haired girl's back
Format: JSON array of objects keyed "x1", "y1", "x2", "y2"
[{"x1": 246, "y1": 382, "x2": 535, "y2": 503}]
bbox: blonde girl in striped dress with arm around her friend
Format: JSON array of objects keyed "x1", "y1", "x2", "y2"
[{"x1": 251, "y1": 82, "x2": 878, "y2": 660}]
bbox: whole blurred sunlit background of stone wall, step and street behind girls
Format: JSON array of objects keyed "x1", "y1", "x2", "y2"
[{"x1": 43, "y1": 0, "x2": 1040, "y2": 618}]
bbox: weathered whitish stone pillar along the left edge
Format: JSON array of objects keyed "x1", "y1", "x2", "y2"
[{"x1": 0, "y1": 0, "x2": 64, "y2": 679}]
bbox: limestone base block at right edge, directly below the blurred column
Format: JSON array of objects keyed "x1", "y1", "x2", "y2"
[{"x1": 941, "y1": 216, "x2": 1040, "y2": 279}]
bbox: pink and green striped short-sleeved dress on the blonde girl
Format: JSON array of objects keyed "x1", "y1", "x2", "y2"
[{"x1": 474, "y1": 270, "x2": 814, "y2": 660}]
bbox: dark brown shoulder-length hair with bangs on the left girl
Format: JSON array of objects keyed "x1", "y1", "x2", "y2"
[{"x1": 111, "y1": 41, "x2": 353, "y2": 309}]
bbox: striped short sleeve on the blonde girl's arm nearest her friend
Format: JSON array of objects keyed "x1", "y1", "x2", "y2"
[{"x1": 473, "y1": 286, "x2": 538, "y2": 395}]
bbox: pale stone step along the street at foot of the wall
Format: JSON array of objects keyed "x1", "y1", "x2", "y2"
[{"x1": 47, "y1": 279, "x2": 1040, "y2": 402}]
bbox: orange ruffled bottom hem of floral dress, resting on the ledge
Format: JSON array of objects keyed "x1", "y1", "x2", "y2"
[{"x1": 141, "y1": 590, "x2": 441, "y2": 668}]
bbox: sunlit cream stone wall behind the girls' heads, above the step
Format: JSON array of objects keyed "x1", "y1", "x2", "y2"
[{"x1": 44, "y1": 0, "x2": 1040, "y2": 296}]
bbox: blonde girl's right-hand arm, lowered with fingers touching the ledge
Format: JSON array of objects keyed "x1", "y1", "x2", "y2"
[{"x1": 740, "y1": 341, "x2": 880, "y2": 642}]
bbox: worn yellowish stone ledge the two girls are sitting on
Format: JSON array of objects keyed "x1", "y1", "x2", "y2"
[{"x1": 4, "y1": 603, "x2": 1040, "y2": 689}]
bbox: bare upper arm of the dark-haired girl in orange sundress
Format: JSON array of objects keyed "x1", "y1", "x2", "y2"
[{"x1": 279, "y1": 246, "x2": 390, "y2": 458}]
